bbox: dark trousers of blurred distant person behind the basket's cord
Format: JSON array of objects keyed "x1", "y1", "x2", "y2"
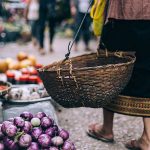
[{"x1": 75, "y1": 12, "x2": 91, "y2": 45}]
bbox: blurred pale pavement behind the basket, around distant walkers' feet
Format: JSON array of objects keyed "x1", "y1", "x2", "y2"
[{"x1": 0, "y1": 37, "x2": 97, "y2": 65}]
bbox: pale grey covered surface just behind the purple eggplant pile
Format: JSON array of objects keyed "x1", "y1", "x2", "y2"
[{"x1": 0, "y1": 99, "x2": 58, "y2": 125}]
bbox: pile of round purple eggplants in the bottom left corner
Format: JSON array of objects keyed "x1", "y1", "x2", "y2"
[{"x1": 0, "y1": 112, "x2": 76, "y2": 150}]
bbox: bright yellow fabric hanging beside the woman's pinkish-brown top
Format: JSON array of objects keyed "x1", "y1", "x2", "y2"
[{"x1": 90, "y1": 0, "x2": 106, "y2": 36}]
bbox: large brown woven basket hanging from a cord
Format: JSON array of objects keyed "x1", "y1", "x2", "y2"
[{"x1": 38, "y1": 52, "x2": 135, "y2": 108}]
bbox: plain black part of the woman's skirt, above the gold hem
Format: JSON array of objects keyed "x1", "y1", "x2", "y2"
[{"x1": 101, "y1": 20, "x2": 150, "y2": 98}]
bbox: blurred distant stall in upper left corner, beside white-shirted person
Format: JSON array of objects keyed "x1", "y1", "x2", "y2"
[{"x1": 0, "y1": 0, "x2": 31, "y2": 43}]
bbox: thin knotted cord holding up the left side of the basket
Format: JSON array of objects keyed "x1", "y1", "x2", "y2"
[{"x1": 63, "y1": 0, "x2": 93, "y2": 62}]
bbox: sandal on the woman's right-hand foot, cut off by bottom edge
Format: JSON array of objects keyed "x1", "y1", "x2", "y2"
[{"x1": 125, "y1": 140, "x2": 141, "y2": 150}]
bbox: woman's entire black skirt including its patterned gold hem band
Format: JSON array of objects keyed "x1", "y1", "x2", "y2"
[{"x1": 101, "y1": 20, "x2": 150, "y2": 116}]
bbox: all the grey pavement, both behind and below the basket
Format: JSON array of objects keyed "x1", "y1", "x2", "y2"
[{"x1": 0, "y1": 37, "x2": 143, "y2": 150}]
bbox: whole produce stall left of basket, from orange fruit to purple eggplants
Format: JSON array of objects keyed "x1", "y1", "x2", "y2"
[{"x1": 0, "y1": 52, "x2": 75, "y2": 150}]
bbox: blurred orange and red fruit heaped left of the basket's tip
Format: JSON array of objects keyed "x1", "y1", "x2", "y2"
[{"x1": 0, "y1": 52, "x2": 42, "y2": 84}]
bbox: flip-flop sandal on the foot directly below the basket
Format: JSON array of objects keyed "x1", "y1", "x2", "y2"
[{"x1": 87, "y1": 123, "x2": 114, "y2": 143}]
